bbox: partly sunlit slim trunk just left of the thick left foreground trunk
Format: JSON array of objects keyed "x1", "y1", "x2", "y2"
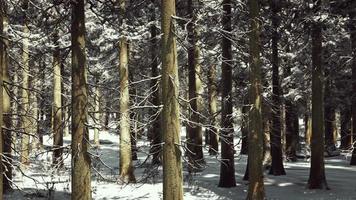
[{"x1": 52, "y1": 33, "x2": 63, "y2": 167}]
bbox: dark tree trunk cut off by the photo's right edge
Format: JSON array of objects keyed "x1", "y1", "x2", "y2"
[{"x1": 349, "y1": 6, "x2": 356, "y2": 165}]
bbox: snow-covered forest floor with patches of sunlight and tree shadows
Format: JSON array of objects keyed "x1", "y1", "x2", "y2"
[{"x1": 5, "y1": 129, "x2": 356, "y2": 200}]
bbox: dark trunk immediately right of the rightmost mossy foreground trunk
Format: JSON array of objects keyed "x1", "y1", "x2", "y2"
[{"x1": 269, "y1": 1, "x2": 286, "y2": 176}]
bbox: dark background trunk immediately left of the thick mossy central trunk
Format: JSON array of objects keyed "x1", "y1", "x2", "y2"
[{"x1": 150, "y1": 0, "x2": 162, "y2": 164}]
